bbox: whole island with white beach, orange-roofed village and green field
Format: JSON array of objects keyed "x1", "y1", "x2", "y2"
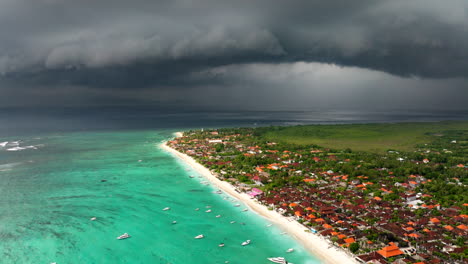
[{"x1": 164, "y1": 122, "x2": 468, "y2": 264}]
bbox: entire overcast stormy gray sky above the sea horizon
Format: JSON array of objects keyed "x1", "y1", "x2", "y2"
[{"x1": 0, "y1": 0, "x2": 468, "y2": 111}]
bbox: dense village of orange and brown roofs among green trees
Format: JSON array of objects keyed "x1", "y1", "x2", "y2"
[{"x1": 169, "y1": 129, "x2": 468, "y2": 264}]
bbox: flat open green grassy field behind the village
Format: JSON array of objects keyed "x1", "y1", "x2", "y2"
[{"x1": 262, "y1": 121, "x2": 468, "y2": 152}]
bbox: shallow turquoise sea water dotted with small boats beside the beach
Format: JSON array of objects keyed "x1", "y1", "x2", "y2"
[{"x1": 0, "y1": 130, "x2": 320, "y2": 264}]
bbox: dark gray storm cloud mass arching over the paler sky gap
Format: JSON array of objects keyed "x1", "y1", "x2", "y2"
[{"x1": 0, "y1": 0, "x2": 468, "y2": 83}]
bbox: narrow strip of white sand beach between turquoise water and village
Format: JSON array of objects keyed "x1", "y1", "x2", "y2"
[{"x1": 161, "y1": 132, "x2": 357, "y2": 264}]
